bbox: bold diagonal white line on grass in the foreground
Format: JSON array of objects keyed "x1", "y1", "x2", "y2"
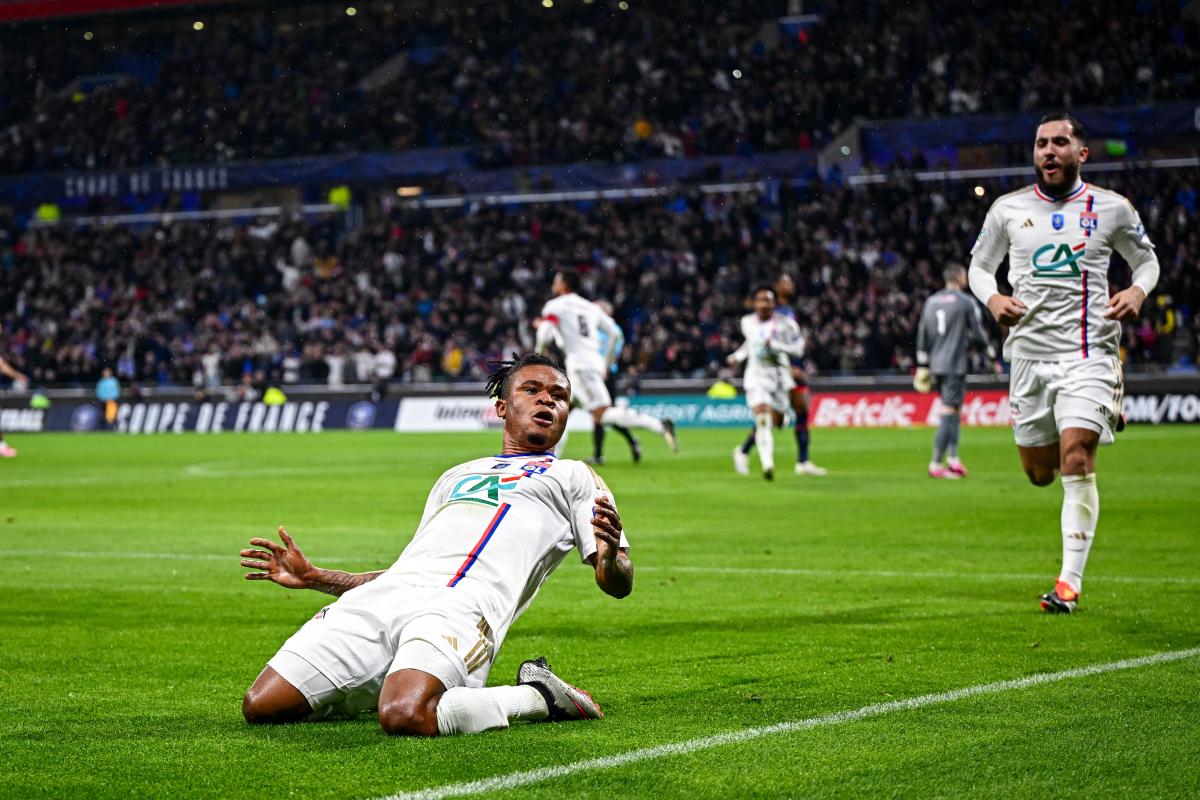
[{"x1": 379, "y1": 648, "x2": 1200, "y2": 800}]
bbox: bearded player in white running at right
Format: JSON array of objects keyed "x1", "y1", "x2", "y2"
[{"x1": 967, "y1": 114, "x2": 1158, "y2": 613}]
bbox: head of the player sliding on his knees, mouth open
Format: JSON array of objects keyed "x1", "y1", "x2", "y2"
[{"x1": 496, "y1": 365, "x2": 571, "y2": 452}]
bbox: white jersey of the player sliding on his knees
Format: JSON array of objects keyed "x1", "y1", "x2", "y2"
[{"x1": 355, "y1": 453, "x2": 629, "y2": 646}]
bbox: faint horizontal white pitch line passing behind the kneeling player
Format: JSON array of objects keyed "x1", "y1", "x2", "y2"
[{"x1": 0, "y1": 551, "x2": 1200, "y2": 585}]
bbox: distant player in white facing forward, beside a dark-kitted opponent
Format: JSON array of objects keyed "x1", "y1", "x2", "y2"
[{"x1": 727, "y1": 287, "x2": 804, "y2": 481}]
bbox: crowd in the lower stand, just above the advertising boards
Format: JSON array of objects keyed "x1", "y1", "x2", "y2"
[{"x1": 0, "y1": 169, "x2": 1200, "y2": 387}]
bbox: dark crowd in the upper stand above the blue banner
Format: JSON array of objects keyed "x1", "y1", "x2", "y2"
[{"x1": 0, "y1": 0, "x2": 1200, "y2": 173}]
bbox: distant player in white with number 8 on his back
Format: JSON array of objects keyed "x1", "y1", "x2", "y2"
[{"x1": 534, "y1": 270, "x2": 679, "y2": 462}]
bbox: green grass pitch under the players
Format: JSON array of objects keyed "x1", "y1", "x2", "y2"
[{"x1": 0, "y1": 427, "x2": 1200, "y2": 800}]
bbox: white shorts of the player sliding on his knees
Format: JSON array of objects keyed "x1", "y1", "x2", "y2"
[{"x1": 268, "y1": 582, "x2": 496, "y2": 718}]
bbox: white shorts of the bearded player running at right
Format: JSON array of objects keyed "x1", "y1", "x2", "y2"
[{"x1": 1008, "y1": 355, "x2": 1124, "y2": 447}]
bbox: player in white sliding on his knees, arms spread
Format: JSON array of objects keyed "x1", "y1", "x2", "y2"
[{"x1": 241, "y1": 355, "x2": 634, "y2": 736}]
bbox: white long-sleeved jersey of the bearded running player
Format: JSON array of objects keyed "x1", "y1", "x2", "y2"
[{"x1": 971, "y1": 184, "x2": 1154, "y2": 361}]
